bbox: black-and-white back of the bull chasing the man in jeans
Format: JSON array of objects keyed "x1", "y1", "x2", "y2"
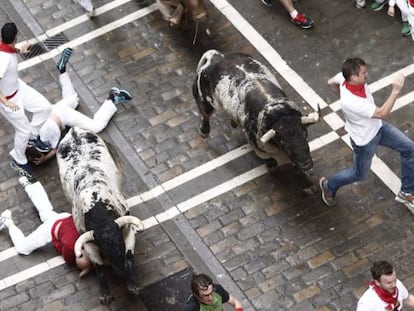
[{"x1": 196, "y1": 50, "x2": 286, "y2": 126}]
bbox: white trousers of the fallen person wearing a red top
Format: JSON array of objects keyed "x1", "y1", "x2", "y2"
[{"x1": 8, "y1": 182, "x2": 70, "y2": 255}]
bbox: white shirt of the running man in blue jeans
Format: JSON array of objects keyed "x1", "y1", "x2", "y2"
[{"x1": 334, "y1": 73, "x2": 382, "y2": 146}]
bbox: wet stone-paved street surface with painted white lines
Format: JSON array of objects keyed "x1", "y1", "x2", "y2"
[{"x1": 0, "y1": 0, "x2": 414, "y2": 311}]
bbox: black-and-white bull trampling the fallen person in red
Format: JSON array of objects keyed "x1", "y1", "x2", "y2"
[{"x1": 57, "y1": 127, "x2": 143, "y2": 304}]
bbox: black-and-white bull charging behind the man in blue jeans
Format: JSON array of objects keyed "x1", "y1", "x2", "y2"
[{"x1": 193, "y1": 50, "x2": 319, "y2": 188}]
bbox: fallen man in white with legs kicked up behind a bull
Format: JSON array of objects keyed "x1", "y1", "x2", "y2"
[{"x1": 29, "y1": 48, "x2": 132, "y2": 164}]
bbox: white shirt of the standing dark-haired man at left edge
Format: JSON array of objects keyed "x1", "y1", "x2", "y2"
[{"x1": 0, "y1": 52, "x2": 19, "y2": 96}]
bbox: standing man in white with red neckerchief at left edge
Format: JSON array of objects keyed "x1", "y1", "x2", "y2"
[{"x1": 0, "y1": 23, "x2": 52, "y2": 179}]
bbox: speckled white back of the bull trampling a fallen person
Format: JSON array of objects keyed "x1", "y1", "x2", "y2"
[{"x1": 56, "y1": 128, "x2": 124, "y2": 229}]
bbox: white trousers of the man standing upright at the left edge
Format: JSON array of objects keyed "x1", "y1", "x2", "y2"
[{"x1": 0, "y1": 79, "x2": 52, "y2": 164}]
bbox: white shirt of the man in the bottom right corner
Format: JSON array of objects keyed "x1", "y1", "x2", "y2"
[{"x1": 357, "y1": 280, "x2": 408, "y2": 311}]
